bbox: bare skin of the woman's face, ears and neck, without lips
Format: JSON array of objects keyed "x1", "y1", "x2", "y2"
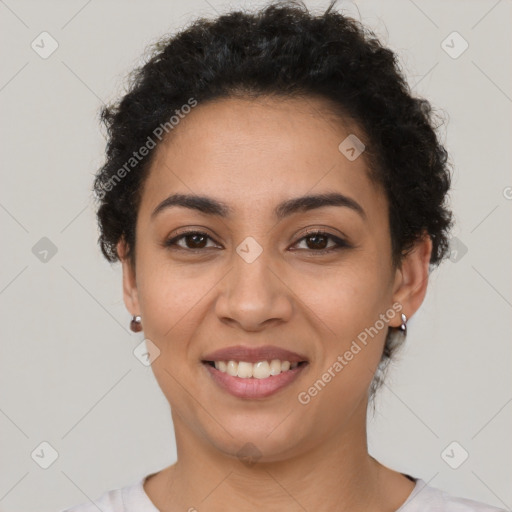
[{"x1": 118, "y1": 98, "x2": 432, "y2": 512}]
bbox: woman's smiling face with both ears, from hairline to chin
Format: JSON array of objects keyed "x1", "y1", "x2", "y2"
[{"x1": 119, "y1": 98, "x2": 430, "y2": 461}]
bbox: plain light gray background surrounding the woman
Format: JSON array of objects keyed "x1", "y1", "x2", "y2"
[{"x1": 0, "y1": 0, "x2": 512, "y2": 512}]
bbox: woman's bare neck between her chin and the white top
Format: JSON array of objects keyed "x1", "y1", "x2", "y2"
[{"x1": 148, "y1": 403, "x2": 414, "y2": 512}]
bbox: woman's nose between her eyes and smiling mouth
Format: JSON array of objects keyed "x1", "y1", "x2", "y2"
[{"x1": 215, "y1": 251, "x2": 293, "y2": 332}]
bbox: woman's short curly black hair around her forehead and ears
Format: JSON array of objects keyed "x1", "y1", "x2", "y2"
[{"x1": 93, "y1": 0, "x2": 452, "y2": 400}]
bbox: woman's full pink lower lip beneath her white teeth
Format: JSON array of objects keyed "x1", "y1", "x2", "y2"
[{"x1": 203, "y1": 363, "x2": 308, "y2": 398}]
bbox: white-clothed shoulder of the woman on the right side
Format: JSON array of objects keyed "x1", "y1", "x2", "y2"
[{"x1": 396, "y1": 479, "x2": 505, "y2": 512}]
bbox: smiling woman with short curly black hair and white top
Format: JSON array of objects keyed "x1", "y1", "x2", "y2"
[{"x1": 63, "y1": 3, "x2": 504, "y2": 512}]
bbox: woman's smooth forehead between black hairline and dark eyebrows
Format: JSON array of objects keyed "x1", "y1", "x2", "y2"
[{"x1": 136, "y1": 98, "x2": 384, "y2": 221}]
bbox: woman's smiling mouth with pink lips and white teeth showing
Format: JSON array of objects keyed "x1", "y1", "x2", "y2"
[{"x1": 201, "y1": 346, "x2": 309, "y2": 399}]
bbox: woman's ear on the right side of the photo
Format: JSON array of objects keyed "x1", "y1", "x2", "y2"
[{"x1": 393, "y1": 233, "x2": 432, "y2": 327}]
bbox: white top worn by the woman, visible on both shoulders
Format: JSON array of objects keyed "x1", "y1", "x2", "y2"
[{"x1": 62, "y1": 475, "x2": 506, "y2": 512}]
